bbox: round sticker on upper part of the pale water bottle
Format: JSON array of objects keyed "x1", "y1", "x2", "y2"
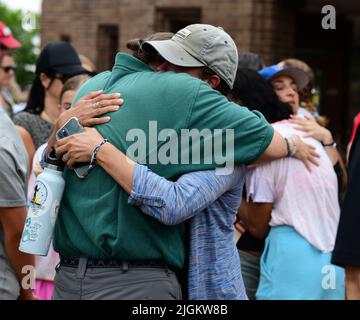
[{"x1": 29, "y1": 180, "x2": 52, "y2": 218}]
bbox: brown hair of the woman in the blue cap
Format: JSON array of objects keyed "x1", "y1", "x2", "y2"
[{"x1": 281, "y1": 58, "x2": 329, "y2": 127}]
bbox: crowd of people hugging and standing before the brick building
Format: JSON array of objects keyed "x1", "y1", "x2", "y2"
[{"x1": 0, "y1": 23, "x2": 360, "y2": 300}]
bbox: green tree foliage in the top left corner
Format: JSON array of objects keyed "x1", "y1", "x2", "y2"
[{"x1": 0, "y1": 3, "x2": 40, "y2": 86}]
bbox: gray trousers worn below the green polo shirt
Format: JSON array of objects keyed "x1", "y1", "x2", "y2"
[{"x1": 52, "y1": 257, "x2": 182, "y2": 300}]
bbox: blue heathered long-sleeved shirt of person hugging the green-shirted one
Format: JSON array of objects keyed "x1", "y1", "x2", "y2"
[{"x1": 129, "y1": 164, "x2": 247, "y2": 300}]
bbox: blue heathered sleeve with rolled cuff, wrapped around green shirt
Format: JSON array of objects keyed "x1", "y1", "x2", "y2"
[{"x1": 128, "y1": 164, "x2": 240, "y2": 225}]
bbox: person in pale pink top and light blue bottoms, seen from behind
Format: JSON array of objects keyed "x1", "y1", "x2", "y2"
[{"x1": 239, "y1": 70, "x2": 345, "y2": 300}]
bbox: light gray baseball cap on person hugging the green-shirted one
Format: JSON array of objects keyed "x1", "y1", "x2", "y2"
[{"x1": 142, "y1": 24, "x2": 238, "y2": 88}]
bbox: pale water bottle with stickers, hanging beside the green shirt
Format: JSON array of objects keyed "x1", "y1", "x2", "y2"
[{"x1": 19, "y1": 152, "x2": 65, "y2": 256}]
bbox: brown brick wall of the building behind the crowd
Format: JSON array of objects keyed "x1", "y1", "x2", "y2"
[{"x1": 41, "y1": 0, "x2": 294, "y2": 69}]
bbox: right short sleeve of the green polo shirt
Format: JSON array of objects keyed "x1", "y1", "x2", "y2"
[{"x1": 189, "y1": 83, "x2": 274, "y2": 165}]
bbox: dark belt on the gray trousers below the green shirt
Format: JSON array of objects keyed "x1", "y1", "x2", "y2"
[{"x1": 60, "y1": 256, "x2": 174, "y2": 271}]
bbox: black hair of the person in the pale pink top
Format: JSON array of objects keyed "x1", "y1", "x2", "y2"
[{"x1": 229, "y1": 68, "x2": 293, "y2": 123}]
